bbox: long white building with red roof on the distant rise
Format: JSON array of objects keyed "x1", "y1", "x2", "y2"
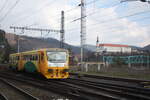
[{"x1": 97, "y1": 44, "x2": 132, "y2": 53}]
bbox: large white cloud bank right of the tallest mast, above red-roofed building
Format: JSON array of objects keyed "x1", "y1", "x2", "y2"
[{"x1": 84, "y1": 1, "x2": 150, "y2": 46}]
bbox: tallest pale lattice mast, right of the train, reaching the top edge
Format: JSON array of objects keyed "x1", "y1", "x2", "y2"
[{"x1": 80, "y1": 0, "x2": 86, "y2": 64}]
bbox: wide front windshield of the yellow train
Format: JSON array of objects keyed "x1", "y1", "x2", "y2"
[{"x1": 47, "y1": 51, "x2": 67, "y2": 63}]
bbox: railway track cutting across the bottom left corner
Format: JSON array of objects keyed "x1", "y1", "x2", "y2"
[{"x1": 0, "y1": 78, "x2": 39, "y2": 100}]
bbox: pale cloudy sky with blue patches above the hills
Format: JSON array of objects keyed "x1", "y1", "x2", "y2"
[{"x1": 0, "y1": 0, "x2": 150, "y2": 47}]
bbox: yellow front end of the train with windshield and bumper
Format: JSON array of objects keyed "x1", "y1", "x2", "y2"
[{"x1": 45, "y1": 50, "x2": 69, "y2": 79}]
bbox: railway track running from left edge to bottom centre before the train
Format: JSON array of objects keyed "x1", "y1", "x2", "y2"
[{"x1": 0, "y1": 73, "x2": 101, "y2": 100}]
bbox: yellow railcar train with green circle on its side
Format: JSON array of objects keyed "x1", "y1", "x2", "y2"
[{"x1": 9, "y1": 48, "x2": 69, "y2": 79}]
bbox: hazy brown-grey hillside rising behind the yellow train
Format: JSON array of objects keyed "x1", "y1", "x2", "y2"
[{"x1": 6, "y1": 33, "x2": 84, "y2": 54}]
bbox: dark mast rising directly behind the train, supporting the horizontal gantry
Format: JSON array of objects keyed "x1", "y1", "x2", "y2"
[{"x1": 60, "y1": 11, "x2": 65, "y2": 48}]
